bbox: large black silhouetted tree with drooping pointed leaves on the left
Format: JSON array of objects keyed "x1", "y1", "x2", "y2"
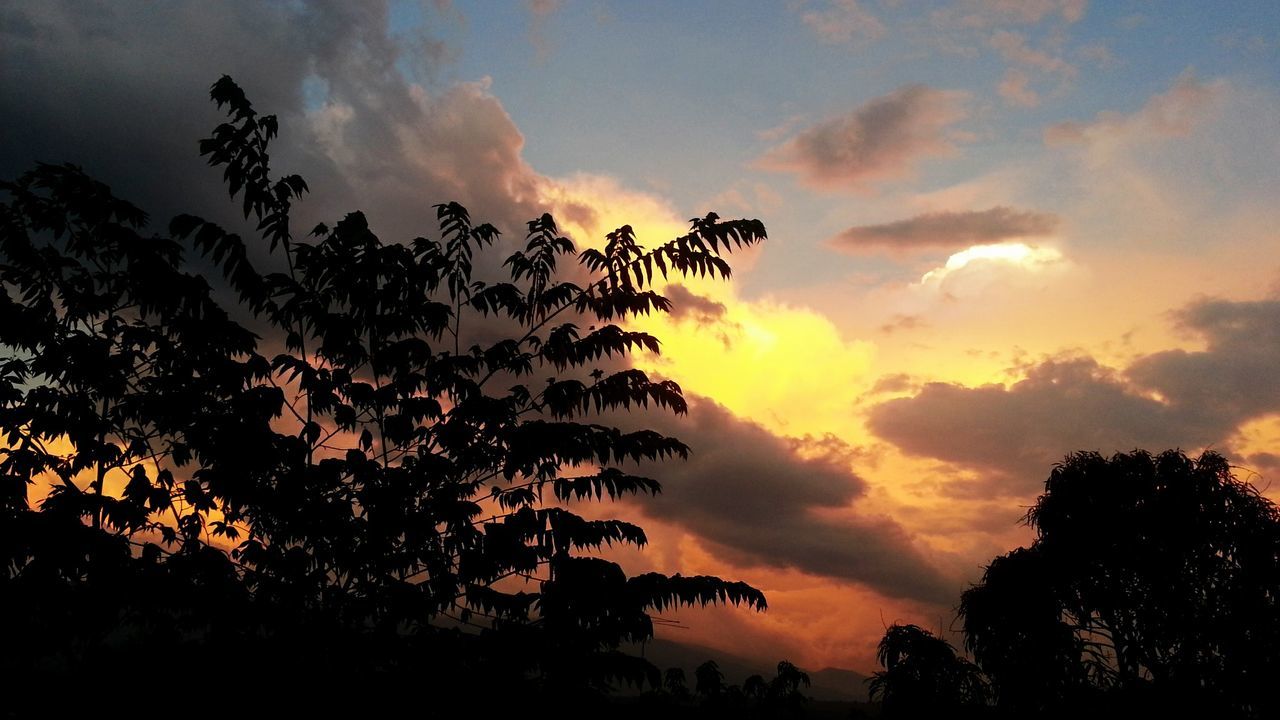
[{"x1": 0, "y1": 77, "x2": 765, "y2": 707}]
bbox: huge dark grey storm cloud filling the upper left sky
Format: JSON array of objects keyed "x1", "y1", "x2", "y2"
[{"x1": 0, "y1": 1, "x2": 543, "y2": 251}]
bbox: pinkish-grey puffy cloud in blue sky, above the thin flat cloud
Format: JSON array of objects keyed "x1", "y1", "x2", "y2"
[{"x1": 759, "y1": 85, "x2": 966, "y2": 190}]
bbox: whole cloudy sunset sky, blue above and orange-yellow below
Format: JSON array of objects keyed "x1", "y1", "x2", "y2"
[{"x1": 0, "y1": 0, "x2": 1280, "y2": 671}]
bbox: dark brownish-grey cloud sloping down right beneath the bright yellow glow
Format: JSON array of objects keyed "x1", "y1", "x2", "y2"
[{"x1": 634, "y1": 398, "x2": 956, "y2": 603}]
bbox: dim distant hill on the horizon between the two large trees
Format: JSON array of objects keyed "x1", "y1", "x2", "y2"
[{"x1": 630, "y1": 639, "x2": 867, "y2": 702}]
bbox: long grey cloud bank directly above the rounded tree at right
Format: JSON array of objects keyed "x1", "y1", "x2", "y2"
[{"x1": 869, "y1": 299, "x2": 1280, "y2": 495}]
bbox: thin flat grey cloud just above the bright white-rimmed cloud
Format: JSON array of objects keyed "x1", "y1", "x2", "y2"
[{"x1": 828, "y1": 205, "x2": 1060, "y2": 252}]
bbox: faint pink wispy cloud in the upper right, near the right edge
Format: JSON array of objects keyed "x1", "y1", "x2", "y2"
[{"x1": 1044, "y1": 76, "x2": 1228, "y2": 145}]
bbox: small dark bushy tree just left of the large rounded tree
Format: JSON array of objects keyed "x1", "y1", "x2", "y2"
[{"x1": 870, "y1": 624, "x2": 988, "y2": 717}]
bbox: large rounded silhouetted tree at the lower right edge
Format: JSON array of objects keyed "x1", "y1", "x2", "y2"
[{"x1": 960, "y1": 451, "x2": 1280, "y2": 716}]
